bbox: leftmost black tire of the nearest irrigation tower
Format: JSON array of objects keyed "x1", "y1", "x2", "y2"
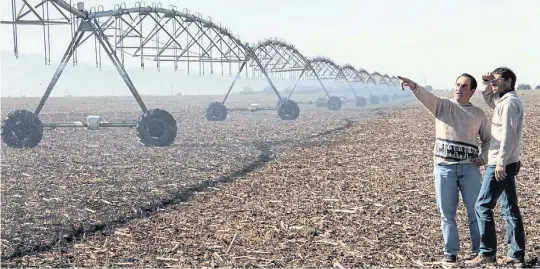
[{"x1": 1, "y1": 109, "x2": 43, "y2": 148}]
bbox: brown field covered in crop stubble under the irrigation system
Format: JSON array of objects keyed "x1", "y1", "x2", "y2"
[{"x1": 1, "y1": 92, "x2": 540, "y2": 267}]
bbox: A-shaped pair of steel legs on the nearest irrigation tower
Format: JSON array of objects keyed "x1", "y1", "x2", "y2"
[{"x1": 35, "y1": 19, "x2": 148, "y2": 115}]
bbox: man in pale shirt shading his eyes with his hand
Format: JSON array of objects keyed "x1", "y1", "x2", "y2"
[{"x1": 468, "y1": 67, "x2": 525, "y2": 266}]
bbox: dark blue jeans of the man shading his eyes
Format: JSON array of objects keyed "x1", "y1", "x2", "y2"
[{"x1": 476, "y1": 162, "x2": 525, "y2": 258}]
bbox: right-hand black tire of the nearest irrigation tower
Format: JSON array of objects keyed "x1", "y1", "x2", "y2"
[{"x1": 137, "y1": 108, "x2": 178, "y2": 147}]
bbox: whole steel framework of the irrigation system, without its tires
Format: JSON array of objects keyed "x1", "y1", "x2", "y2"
[{"x1": 1, "y1": 0, "x2": 408, "y2": 148}]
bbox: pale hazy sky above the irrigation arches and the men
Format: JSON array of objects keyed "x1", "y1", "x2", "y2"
[{"x1": 0, "y1": 0, "x2": 540, "y2": 94}]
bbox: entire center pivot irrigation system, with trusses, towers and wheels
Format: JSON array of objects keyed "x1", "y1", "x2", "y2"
[{"x1": 1, "y1": 0, "x2": 398, "y2": 148}]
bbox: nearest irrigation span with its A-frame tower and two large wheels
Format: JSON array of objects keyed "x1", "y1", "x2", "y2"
[{"x1": 2, "y1": 0, "x2": 274, "y2": 147}]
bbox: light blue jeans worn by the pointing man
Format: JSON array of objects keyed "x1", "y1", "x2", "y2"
[{"x1": 433, "y1": 164, "x2": 482, "y2": 255}]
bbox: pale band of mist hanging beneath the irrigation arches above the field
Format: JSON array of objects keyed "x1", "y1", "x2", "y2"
[{"x1": 0, "y1": 50, "x2": 399, "y2": 100}]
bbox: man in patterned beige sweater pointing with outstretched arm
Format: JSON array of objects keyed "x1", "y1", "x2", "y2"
[{"x1": 398, "y1": 73, "x2": 491, "y2": 263}]
